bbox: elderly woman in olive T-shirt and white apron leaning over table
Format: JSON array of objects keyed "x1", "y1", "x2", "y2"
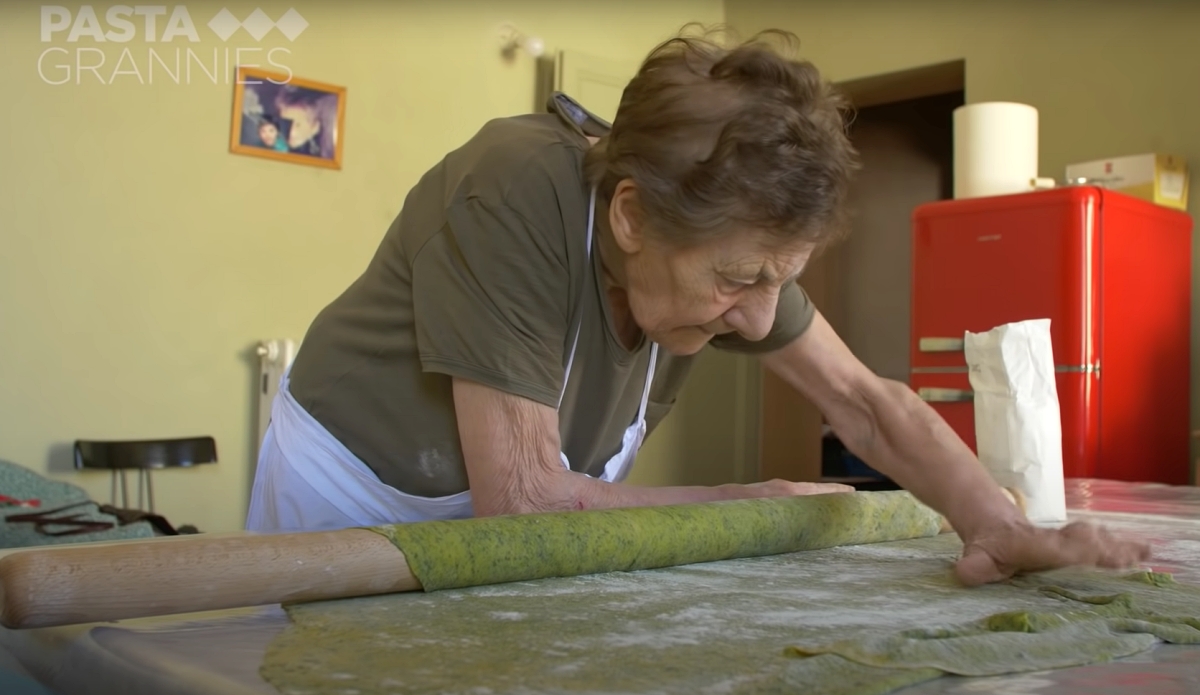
[{"x1": 247, "y1": 31, "x2": 1146, "y2": 583}]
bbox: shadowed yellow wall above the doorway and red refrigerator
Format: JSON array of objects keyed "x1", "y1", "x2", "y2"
[{"x1": 726, "y1": 0, "x2": 1200, "y2": 472}]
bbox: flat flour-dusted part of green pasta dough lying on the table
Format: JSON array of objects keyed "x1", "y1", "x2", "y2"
[{"x1": 260, "y1": 534, "x2": 1200, "y2": 695}]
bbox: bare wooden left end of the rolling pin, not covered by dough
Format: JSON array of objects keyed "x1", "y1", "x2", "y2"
[{"x1": 0, "y1": 529, "x2": 421, "y2": 629}]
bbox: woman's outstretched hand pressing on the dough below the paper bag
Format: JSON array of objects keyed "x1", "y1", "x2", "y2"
[{"x1": 955, "y1": 520, "x2": 1151, "y2": 586}]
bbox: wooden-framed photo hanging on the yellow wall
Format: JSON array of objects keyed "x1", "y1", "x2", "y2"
[{"x1": 229, "y1": 66, "x2": 346, "y2": 169}]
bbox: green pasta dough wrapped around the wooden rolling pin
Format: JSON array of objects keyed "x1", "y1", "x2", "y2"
[{"x1": 370, "y1": 491, "x2": 941, "y2": 591}]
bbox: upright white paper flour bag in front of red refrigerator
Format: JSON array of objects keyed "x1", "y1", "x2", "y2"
[{"x1": 964, "y1": 318, "x2": 1067, "y2": 523}]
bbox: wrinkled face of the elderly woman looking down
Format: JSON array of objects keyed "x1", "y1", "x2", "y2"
[{"x1": 610, "y1": 184, "x2": 814, "y2": 355}]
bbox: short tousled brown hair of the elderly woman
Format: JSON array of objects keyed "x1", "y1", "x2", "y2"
[{"x1": 584, "y1": 25, "x2": 858, "y2": 245}]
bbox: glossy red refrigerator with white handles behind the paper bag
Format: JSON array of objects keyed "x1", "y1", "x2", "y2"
[{"x1": 910, "y1": 186, "x2": 1192, "y2": 485}]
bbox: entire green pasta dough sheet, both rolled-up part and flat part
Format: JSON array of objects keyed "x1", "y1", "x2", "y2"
[{"x1": 260, "y1": 493, "x2": 1200, "y2": 695}]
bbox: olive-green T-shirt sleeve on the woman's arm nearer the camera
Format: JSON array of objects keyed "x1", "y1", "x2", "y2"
[{"x1": 413, "y1": 197, "x2": 570, "y2": 406}]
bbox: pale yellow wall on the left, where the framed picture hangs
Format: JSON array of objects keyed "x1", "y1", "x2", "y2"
[{"x1": 0, "y1": 0, "x2": 722, "y2": 531}]
